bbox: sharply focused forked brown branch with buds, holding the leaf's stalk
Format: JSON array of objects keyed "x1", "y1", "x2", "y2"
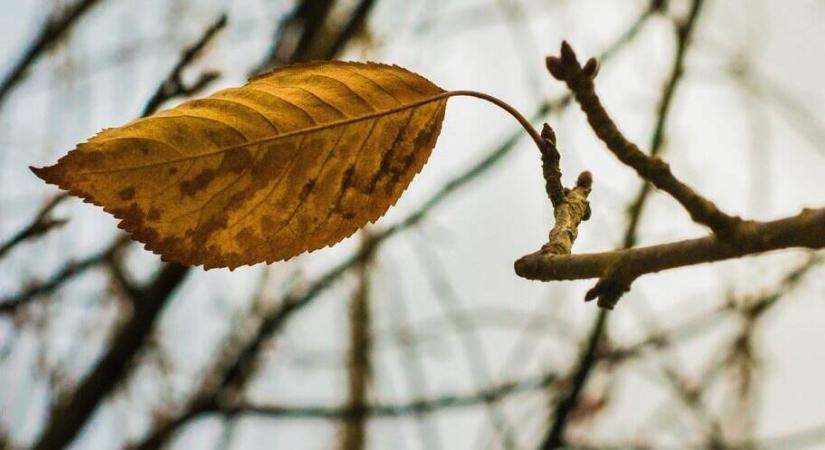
[{"x1": 515, "y1": 42, "x2": 825, "y2": 309}]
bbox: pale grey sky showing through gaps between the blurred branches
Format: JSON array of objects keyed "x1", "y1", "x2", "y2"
[{"x1": 0, "y1": 0, "x2": 825, "y2": 450}]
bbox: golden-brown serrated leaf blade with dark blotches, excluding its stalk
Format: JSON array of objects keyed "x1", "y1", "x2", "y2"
[{"x1": 33, "y1": 62, "x2": 447, "y2": 268}]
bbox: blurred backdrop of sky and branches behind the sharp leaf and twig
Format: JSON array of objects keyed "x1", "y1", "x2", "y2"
[{"x1": 0, "y1": 0, "x2": 825, "y2": 450}]
